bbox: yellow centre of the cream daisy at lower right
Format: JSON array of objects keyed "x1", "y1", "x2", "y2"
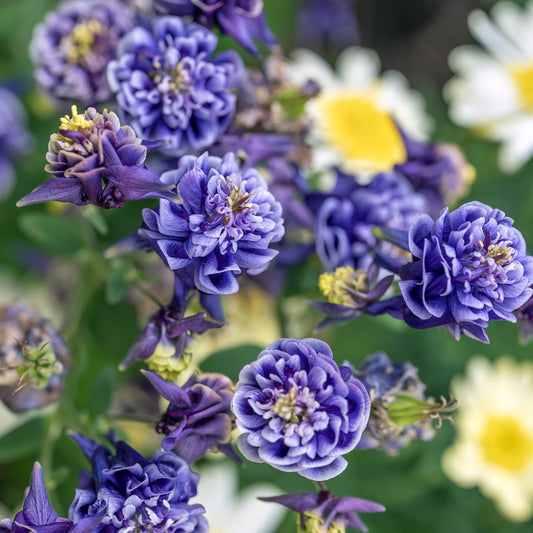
[{"x1": 480, "y1": 416, "x2": 533, "y2": 472}]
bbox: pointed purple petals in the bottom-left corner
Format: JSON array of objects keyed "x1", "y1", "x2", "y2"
[{"x1": 0, "y1": 462, "x2": 102, "y2": 533}]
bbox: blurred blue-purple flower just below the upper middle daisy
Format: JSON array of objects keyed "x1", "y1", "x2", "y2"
[{"x1": 306, "y1": 173, "x2": 426, "y2": 271}]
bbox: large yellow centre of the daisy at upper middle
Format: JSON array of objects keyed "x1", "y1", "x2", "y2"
[{"x1": 315, "y1": 92, "x2": 407, "y2": 172}]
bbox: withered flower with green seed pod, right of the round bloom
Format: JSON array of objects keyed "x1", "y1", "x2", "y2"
[{"x1": 354, "y1": 352, "x2": 456, "y2": 455}]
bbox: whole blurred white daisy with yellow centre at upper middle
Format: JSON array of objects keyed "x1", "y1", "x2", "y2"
[{"x1": 290, "y1": 47, "x2": 431, "y2": 174}]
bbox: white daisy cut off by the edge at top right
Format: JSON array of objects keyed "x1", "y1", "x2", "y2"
[{"x1": 444, "y1": 1, "x2": 533, "y2": 172}]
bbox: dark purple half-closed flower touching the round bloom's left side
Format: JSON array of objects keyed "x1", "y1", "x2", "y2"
[{"x1": 143, "y1": 371, "x2": 234, "y2": 463}]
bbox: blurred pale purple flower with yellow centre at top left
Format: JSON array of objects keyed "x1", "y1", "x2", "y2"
[{"x1": 30, "y1": 0, "x2": 134, "y2": 107}]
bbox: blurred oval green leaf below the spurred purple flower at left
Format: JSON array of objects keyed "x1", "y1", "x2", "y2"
[{"x1": 18, "y1": 213, "x2": 83, "y2": 255}]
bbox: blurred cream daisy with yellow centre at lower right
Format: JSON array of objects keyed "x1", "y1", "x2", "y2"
[{"x1": 442, "y1": 357, "x2": 533, "y2": 522}]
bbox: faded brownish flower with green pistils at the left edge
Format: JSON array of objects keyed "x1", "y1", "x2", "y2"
[{"x1": 0, "y1": 302, "x2": 71, "y2": 411}]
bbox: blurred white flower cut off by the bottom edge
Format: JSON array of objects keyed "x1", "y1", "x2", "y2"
[{"x1": 191, "y1": 462, "x2": 286, "y2": 533}]
